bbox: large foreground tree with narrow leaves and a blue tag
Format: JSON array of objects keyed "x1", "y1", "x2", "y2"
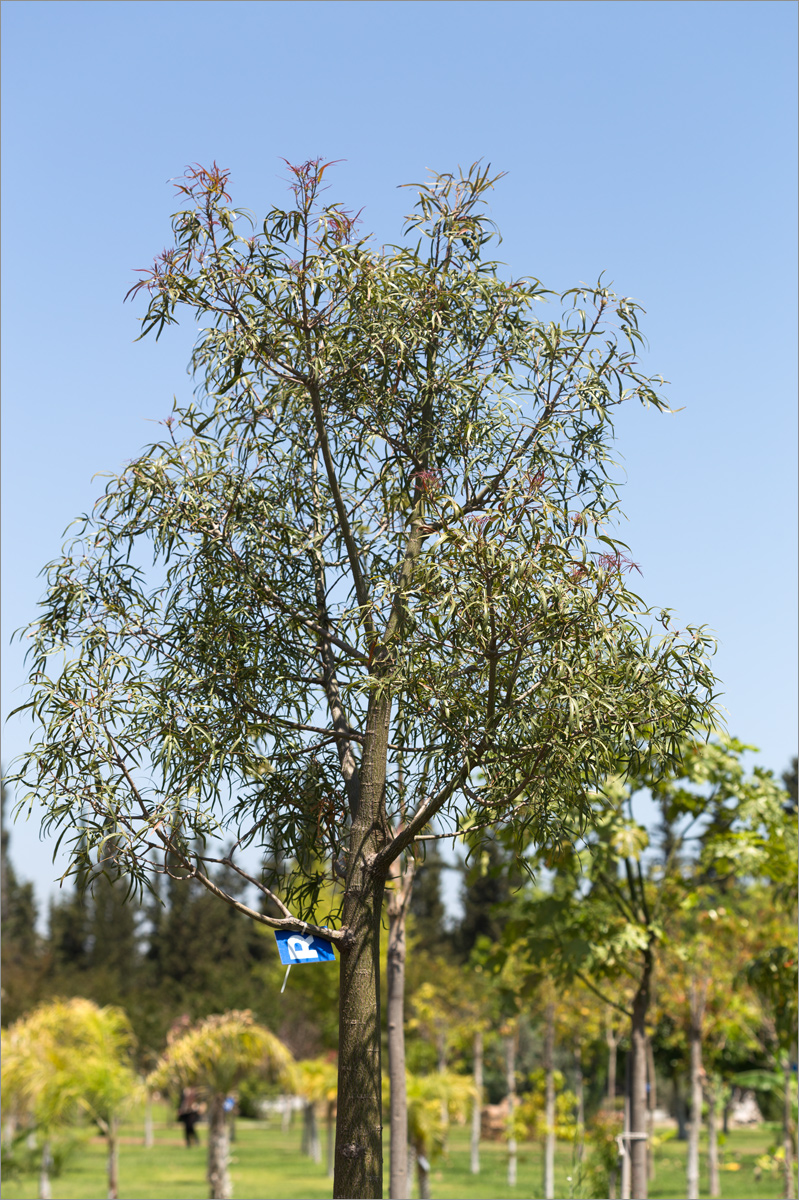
[{"x1": 10, "y1": 160, "x2": 714, "y2": 1198}]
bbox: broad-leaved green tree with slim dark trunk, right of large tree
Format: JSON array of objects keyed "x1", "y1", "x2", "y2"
[{"x1": 506, "y1": 734, "x2": 797, "y2": 1200}]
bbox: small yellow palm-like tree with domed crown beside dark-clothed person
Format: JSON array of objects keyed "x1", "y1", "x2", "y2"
[{"x1": 148, "y1": 1012, "x2": 294, "y2": 1200}]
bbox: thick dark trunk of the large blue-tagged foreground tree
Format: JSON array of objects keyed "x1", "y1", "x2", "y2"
[{"x1": 334, "y1": 692, "x2": 390, "y2": 1200}]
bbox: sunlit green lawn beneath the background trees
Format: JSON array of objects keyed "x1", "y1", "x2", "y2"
[{"x1": 0, "y1": 1106, "x2": 782, "y2": 1200}]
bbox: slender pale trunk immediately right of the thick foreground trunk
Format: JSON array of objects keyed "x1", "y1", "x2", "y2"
[{"x1": 386, "y1": 858, "x2": 415, "y2": 1200}]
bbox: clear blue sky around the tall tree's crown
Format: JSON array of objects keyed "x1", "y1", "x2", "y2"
[{"x1": 1, "y1": 0, "x2": 797, "y2": 916}]
